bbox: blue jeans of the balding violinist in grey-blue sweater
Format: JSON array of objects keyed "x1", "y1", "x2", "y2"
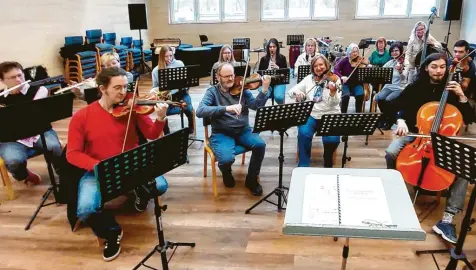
[{"x1": 210, "y1": 126, "x2": 266, "y2": 179}]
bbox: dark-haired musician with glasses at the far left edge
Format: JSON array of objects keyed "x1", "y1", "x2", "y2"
[{"x1": 0, "y1": 62, "x2": 62, "y2": 185}]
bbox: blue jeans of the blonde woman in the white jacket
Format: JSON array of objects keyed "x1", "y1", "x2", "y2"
[{"x1": 298, "y1": 116, "x2": 340, "y2": 168}]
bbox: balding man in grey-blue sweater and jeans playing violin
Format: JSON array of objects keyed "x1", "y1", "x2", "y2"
[{"x1": 197, "y1": 63, "x2": 271, "y2": 196}]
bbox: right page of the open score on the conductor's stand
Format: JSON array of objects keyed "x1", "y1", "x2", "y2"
[{"x1": 339, "y1": 175, "x2": 394, "y2": 227}]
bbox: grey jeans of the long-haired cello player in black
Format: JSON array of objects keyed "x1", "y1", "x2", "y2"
[{"x1": 385, "y1": 137, "x2": 468, "y2": 215}]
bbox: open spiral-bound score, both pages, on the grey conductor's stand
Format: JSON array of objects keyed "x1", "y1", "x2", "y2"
[{"x1": 302, "y1": 174, "x2": 394, "y2": 227}]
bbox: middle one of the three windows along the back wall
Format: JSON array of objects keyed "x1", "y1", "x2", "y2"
[{"x1": 261, "y1": 0, "x2": 337, "y2": 20}]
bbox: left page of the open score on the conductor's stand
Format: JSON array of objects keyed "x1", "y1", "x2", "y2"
[{"x1": 302, "y1": 174, "x2": 339, "y2": 225}]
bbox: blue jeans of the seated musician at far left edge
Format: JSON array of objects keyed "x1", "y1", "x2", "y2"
[{"x1": 0, "y1": 129, "x2": 62, "y2": 181}]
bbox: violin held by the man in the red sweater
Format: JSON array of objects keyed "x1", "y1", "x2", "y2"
[{"x1": 111, "y1": 93, "x2": 187, "y2": 118}]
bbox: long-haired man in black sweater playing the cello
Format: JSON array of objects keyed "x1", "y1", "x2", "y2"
[{"x1": 385, "y1": 53, "x2": 472, "y2": 243}]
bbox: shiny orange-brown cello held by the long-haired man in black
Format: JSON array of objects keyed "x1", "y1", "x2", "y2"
[{"x1": 396, "y1": 54, "x2": 469, "y2": 193}]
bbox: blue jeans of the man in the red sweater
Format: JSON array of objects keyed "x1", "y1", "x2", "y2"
[{"x1": 76, "y1": 171, "x2": 168, "y2": 222}]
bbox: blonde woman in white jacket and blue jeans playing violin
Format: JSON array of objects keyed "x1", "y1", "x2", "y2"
[{"x1": 289, "y1": 54, "x2": 342, "y2": 168}]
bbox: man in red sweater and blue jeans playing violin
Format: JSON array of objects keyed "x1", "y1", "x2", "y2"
[{"x1": 66, "y1": 68, "x2": 168, "y2": 261}]
